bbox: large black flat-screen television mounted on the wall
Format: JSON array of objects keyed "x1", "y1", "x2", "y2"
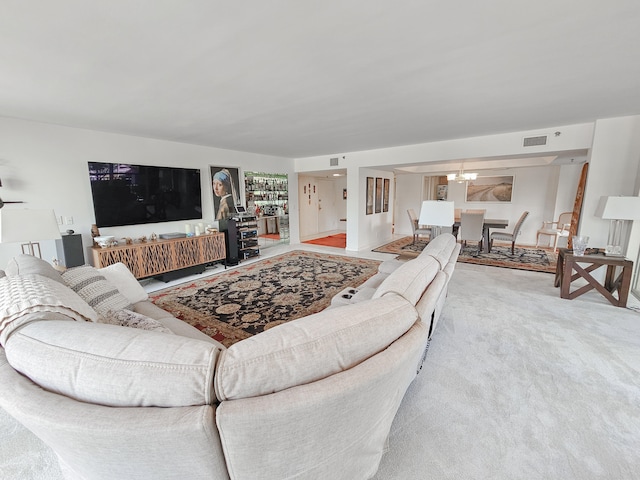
[{"x1": 89, "y1": 162, "x2": 202, "y2": 227}]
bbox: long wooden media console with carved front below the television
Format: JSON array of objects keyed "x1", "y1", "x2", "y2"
[{"x1": 91, "y1": 232, "x2": 226, "y2": 281}]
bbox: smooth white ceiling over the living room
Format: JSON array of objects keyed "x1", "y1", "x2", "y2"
[{"x1": 0, "y1": 0, "x2": 640, "y2": 157}]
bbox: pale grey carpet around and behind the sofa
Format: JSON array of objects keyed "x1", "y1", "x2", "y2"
[{"x1": 0, "y1": 264, "x2": 640, "y2": 480}]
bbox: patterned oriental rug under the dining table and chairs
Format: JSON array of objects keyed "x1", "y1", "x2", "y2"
[{"x1": 374, "y1": 237, "x2": 558, "y2": 273}]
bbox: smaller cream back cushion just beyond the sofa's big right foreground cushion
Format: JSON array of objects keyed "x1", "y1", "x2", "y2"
[{"x1": 373, "y1": 256, "x2": 440, "y2": 305}]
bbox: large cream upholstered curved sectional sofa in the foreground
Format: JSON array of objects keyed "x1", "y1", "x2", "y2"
[{"x1": 0, "y1": 235, "x2": 459, "y2": 480}]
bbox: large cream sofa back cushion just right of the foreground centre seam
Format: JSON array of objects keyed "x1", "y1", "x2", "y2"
[{"x1": 215, "y1": 295, "x2": 418, "y2": 401}]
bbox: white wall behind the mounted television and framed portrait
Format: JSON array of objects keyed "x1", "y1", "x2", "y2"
[{"x1": 0, "y1": 118, "x2": 299, "y2": 268}]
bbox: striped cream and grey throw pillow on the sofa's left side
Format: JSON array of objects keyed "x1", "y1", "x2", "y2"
[{"x1": 62, "y1": 265, "x2": 131, "y2": 315}]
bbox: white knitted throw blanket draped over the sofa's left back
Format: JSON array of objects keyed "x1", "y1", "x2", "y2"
[{"x1": 0, "y1": 274, "x2": 98, "y2": 346}]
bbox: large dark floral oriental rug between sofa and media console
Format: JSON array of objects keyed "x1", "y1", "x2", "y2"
[{"x1": 149, "y1": 250, "x2": 380, "y2": 347}]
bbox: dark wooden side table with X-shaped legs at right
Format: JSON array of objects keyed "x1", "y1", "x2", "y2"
[{"x1": 555, "y1": 248, "x2": 633, "y2": 307}]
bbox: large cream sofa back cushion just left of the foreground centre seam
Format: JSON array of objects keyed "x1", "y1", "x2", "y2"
[{"x1": 6, "y1": 321, "x2": 220, "y2": 407}]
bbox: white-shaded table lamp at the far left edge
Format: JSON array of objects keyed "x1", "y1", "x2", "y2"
[{"x1": 0, "y1": 208, "x2": 61, "y2": 258}]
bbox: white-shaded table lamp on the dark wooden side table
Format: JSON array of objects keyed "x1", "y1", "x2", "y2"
[{"x1": 596, "y1": 196, "x2": 640, "y2": 257}]
